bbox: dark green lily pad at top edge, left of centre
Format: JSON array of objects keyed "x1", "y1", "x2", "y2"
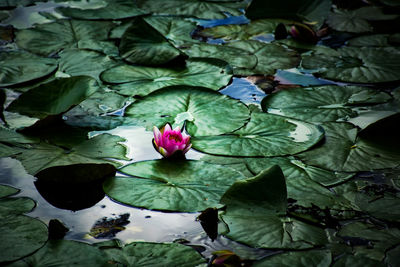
[{"x1": 56, "y1": 0, "x2": 144, "y2": 20}]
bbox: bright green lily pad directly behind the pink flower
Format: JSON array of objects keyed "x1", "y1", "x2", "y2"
[{"x1": 125, "y1": 86, "x2": 249, "y2": 136}]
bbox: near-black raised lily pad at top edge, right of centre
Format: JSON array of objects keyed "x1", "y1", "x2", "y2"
[{"x1": 246, "y1": 0, "x2": 332, "y2": 28}]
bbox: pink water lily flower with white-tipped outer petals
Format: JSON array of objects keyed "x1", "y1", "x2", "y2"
[{"x1": 153, "y1": 123, "x2": 192, "y2": 158}]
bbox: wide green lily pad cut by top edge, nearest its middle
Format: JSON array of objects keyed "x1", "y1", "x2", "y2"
[{"x1": 137, "y1": 0, "x2": 247, "y2": 19}]
